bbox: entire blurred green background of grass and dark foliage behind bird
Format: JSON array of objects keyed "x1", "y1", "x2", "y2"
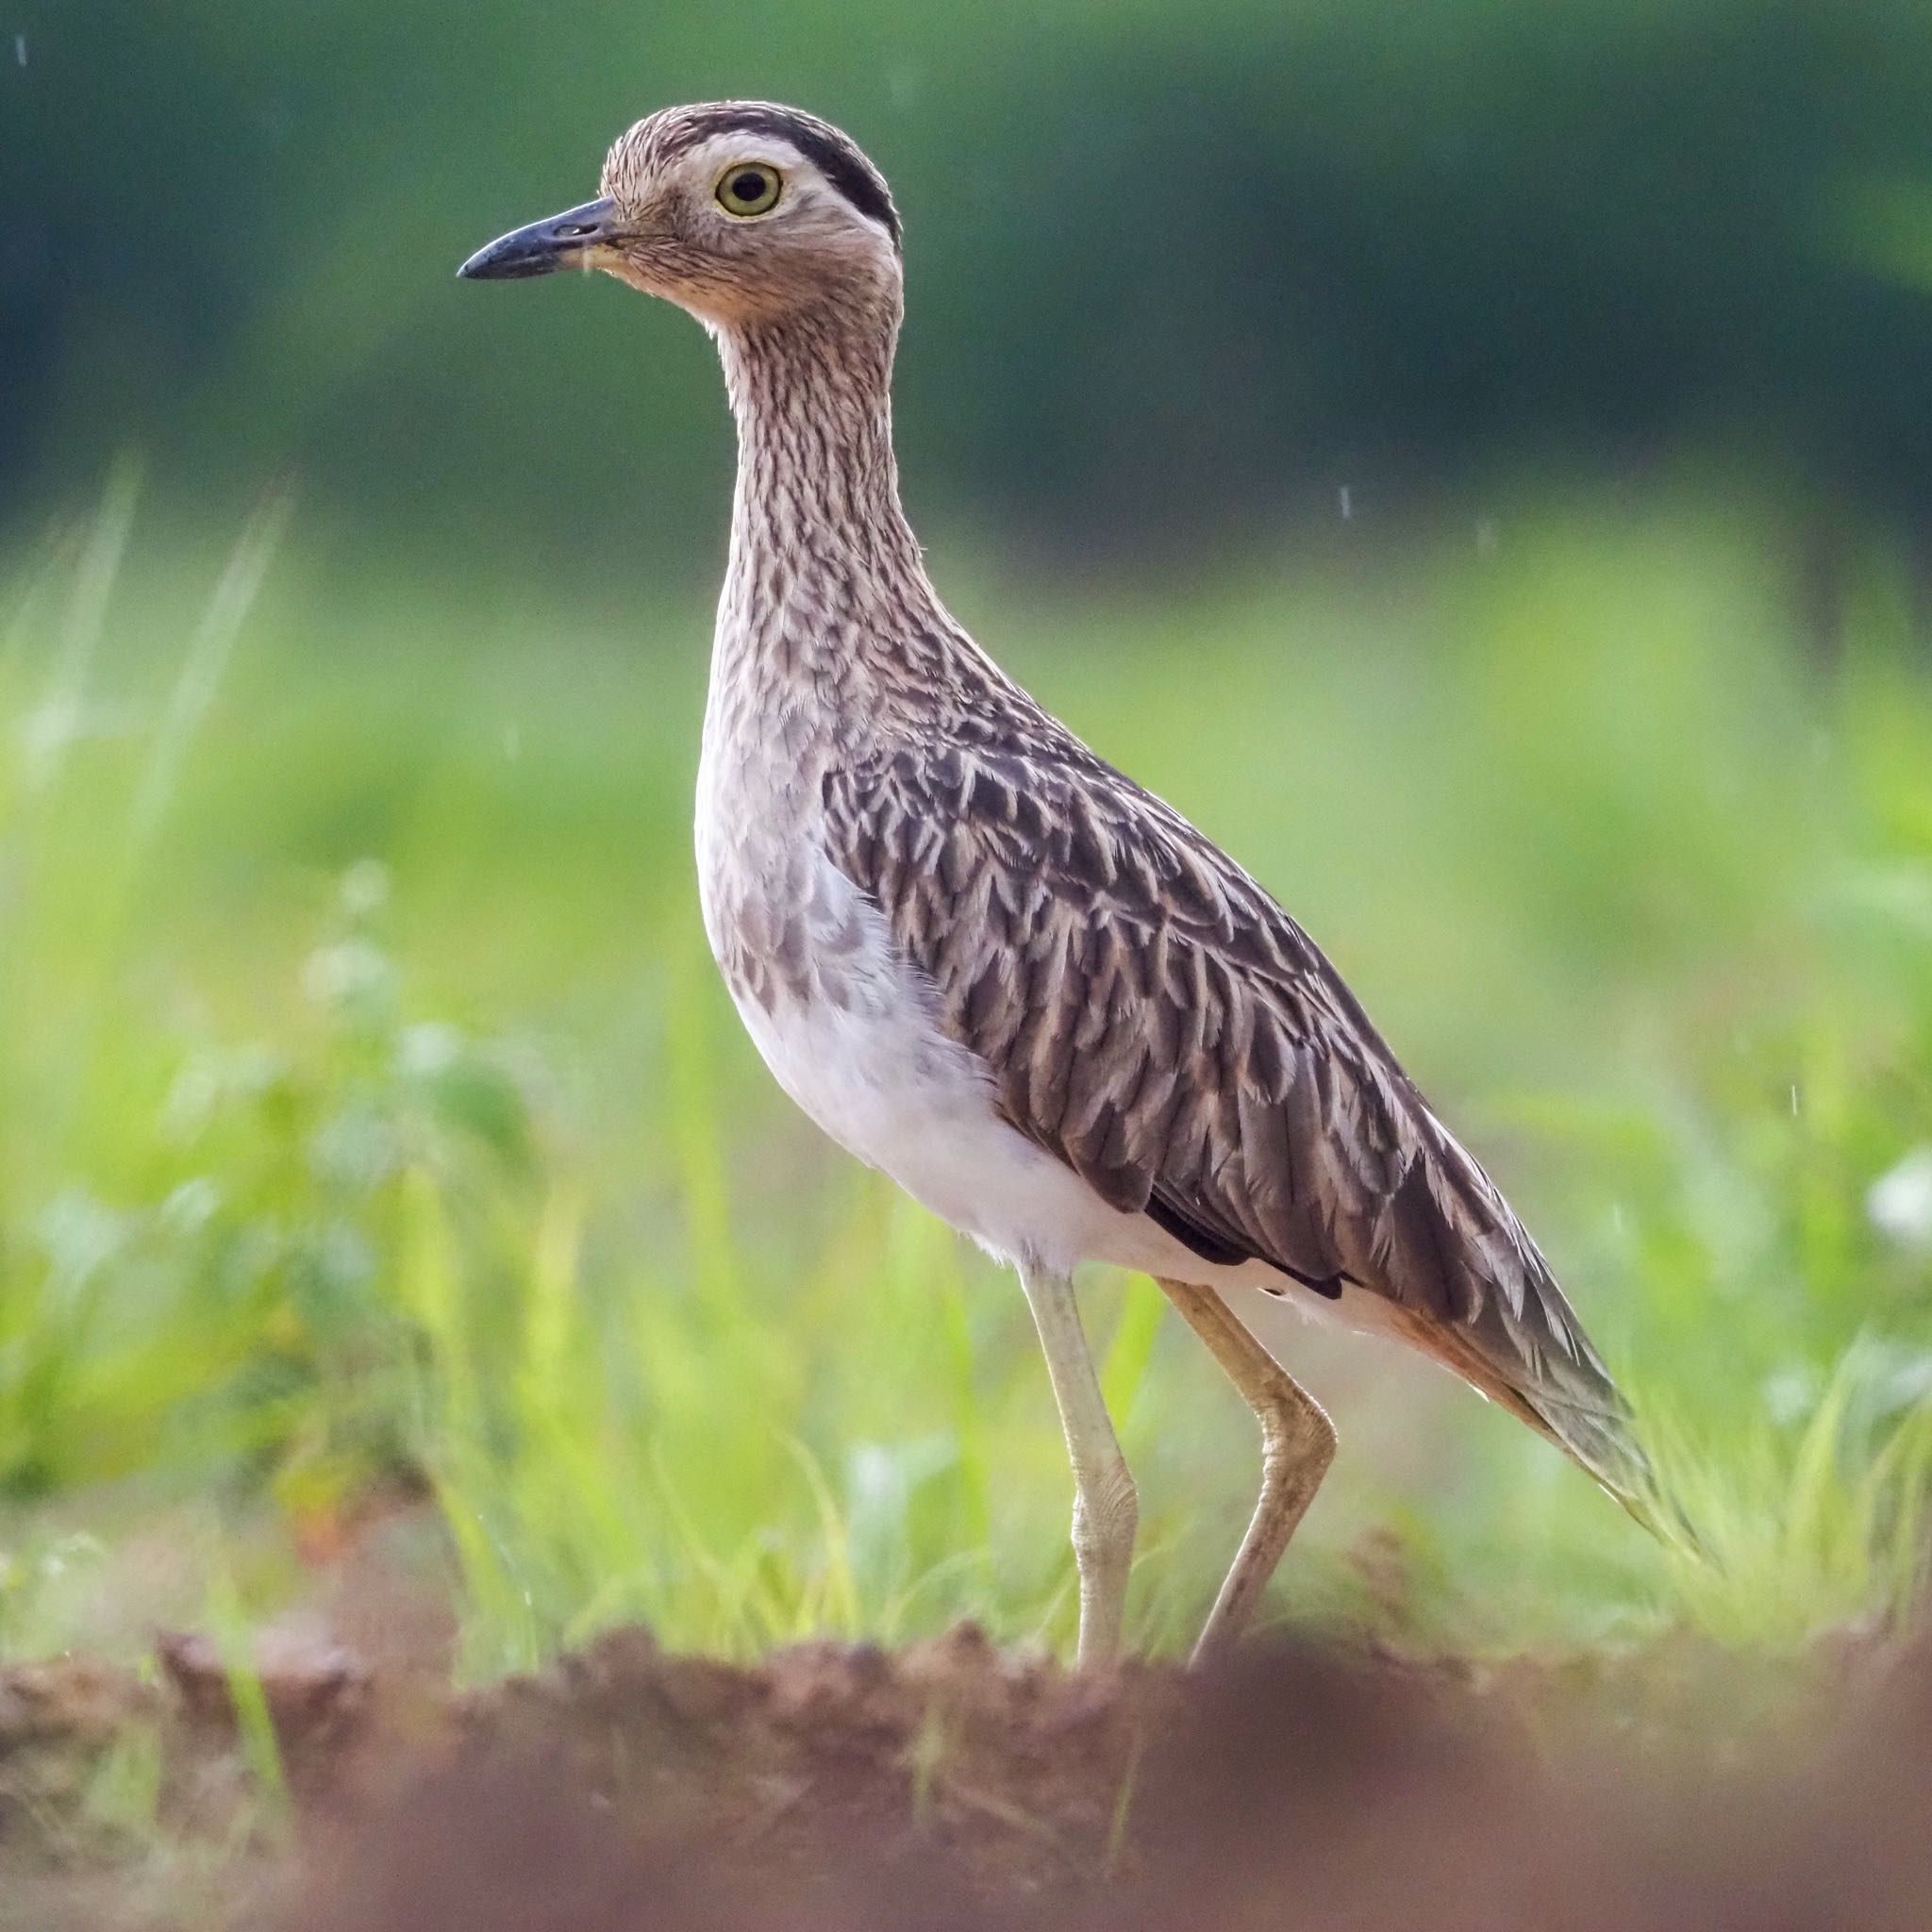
[{"x1": 0, "y1": 0, "x2": 1932, "y2": 1669}]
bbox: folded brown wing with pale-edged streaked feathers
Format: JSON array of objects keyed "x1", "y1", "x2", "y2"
[{"x1": 823, "y1": 738, "x2": 1642, "y2": 1495}]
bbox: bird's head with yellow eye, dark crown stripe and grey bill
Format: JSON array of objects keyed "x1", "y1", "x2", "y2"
[{"x1": 458, "y1": 100, "x2": 900, "y2": 328}]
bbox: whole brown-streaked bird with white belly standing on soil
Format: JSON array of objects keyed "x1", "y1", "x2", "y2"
[{"x1": 458, "y1": 100, "x2": 1650, "y2": 1667}]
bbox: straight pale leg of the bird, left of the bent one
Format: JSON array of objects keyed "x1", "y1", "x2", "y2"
[{"x1": 1020, "y1": 1267, "x2": 1140, "y2": 1663}]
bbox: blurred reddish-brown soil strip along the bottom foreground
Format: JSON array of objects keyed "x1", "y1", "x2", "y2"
[{"x1": 0, "y1": 1628, "x2": 1932, "y2": 1932}]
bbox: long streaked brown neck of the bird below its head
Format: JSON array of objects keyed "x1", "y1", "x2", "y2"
[{"x1": 719, "y1": 301, "x2": 937, "y2": 680}]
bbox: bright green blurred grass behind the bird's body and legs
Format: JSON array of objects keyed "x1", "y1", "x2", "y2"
[{"x1": 0, "y1": 472, "x2": 1932, "y2": 1672}]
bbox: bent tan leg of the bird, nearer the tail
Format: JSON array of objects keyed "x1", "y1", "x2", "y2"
[{"x1": 1161, "y1": 1281, "x2": 1335, "y2": 1665}]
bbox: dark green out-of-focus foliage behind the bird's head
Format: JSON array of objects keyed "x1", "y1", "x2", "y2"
[{"x1": 11, "y1": 0, "x2": 1932, "y2": 575}]
